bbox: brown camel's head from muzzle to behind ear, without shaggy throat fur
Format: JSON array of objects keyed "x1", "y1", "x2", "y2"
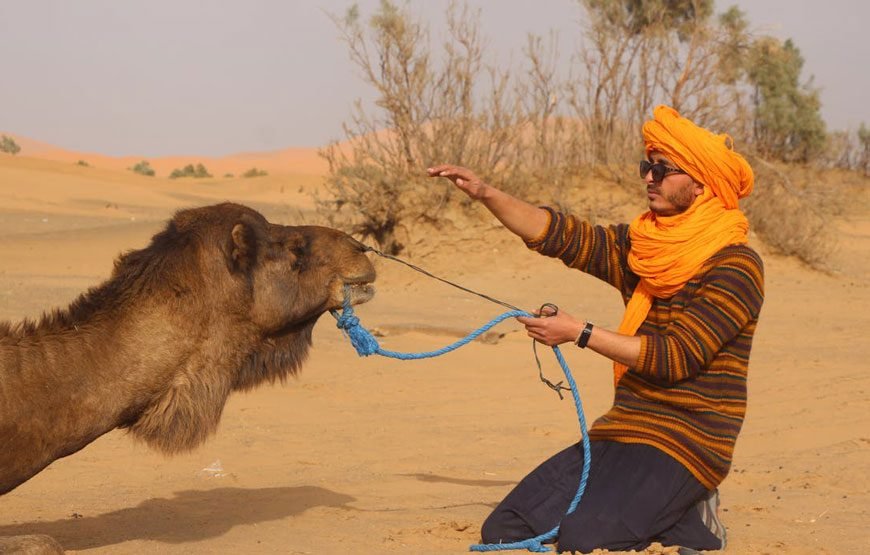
[{"x1": 144, "y1": 203, "x2": 375, "y2": 338}]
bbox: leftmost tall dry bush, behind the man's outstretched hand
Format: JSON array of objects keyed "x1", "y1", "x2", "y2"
[{"x1": 315, "y1": 0, "x2": 523, "y2": 254}]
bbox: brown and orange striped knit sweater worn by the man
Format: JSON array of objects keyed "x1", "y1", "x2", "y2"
[{"x1": 526, "y1": 208, "x2": 764, "y2": 489}]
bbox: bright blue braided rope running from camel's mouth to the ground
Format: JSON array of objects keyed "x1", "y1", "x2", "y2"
[{"x1": 330, "y1": 301, "x2": 591, "y2": 553}]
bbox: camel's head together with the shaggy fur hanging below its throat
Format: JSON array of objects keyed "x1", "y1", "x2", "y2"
[{"x1": 107, "y1": 203, "x2": 375, "y2": 452}]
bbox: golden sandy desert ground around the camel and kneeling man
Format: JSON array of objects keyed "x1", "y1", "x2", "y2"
[{"x1": 0, "y1": 150, "x2": 870, "y2": 555}]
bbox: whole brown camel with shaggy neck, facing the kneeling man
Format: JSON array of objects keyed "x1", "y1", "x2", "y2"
[{"x1": 0, "y1": 203, "x2": 375, "y2": 551}]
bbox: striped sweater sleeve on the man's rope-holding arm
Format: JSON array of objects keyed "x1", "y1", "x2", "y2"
[{"x1": 632, "y1": 249, "x2": 764, "y2": 384}]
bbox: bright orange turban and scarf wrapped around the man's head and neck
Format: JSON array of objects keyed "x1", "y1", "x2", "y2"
[{"x1": 613, "y1": 106, "x2": 754, "y2": 384}]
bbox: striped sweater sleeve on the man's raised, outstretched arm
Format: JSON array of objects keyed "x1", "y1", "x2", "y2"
[{"x1": 526, "y1": 206, "x2": 629, "y2": 291}]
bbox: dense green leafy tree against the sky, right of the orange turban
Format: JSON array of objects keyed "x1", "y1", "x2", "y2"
[{"x1": 747, "y1": 37, "x2": 826, "y2": 162}]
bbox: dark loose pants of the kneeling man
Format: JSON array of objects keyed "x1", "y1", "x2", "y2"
[{"x1": 481, "y1": 441, "x2": 721, "y2": 553}]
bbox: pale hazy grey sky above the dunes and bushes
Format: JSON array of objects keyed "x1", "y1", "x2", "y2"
[{"x1": 0, "y1": 0, "x2": 870, "y2": 156}]
